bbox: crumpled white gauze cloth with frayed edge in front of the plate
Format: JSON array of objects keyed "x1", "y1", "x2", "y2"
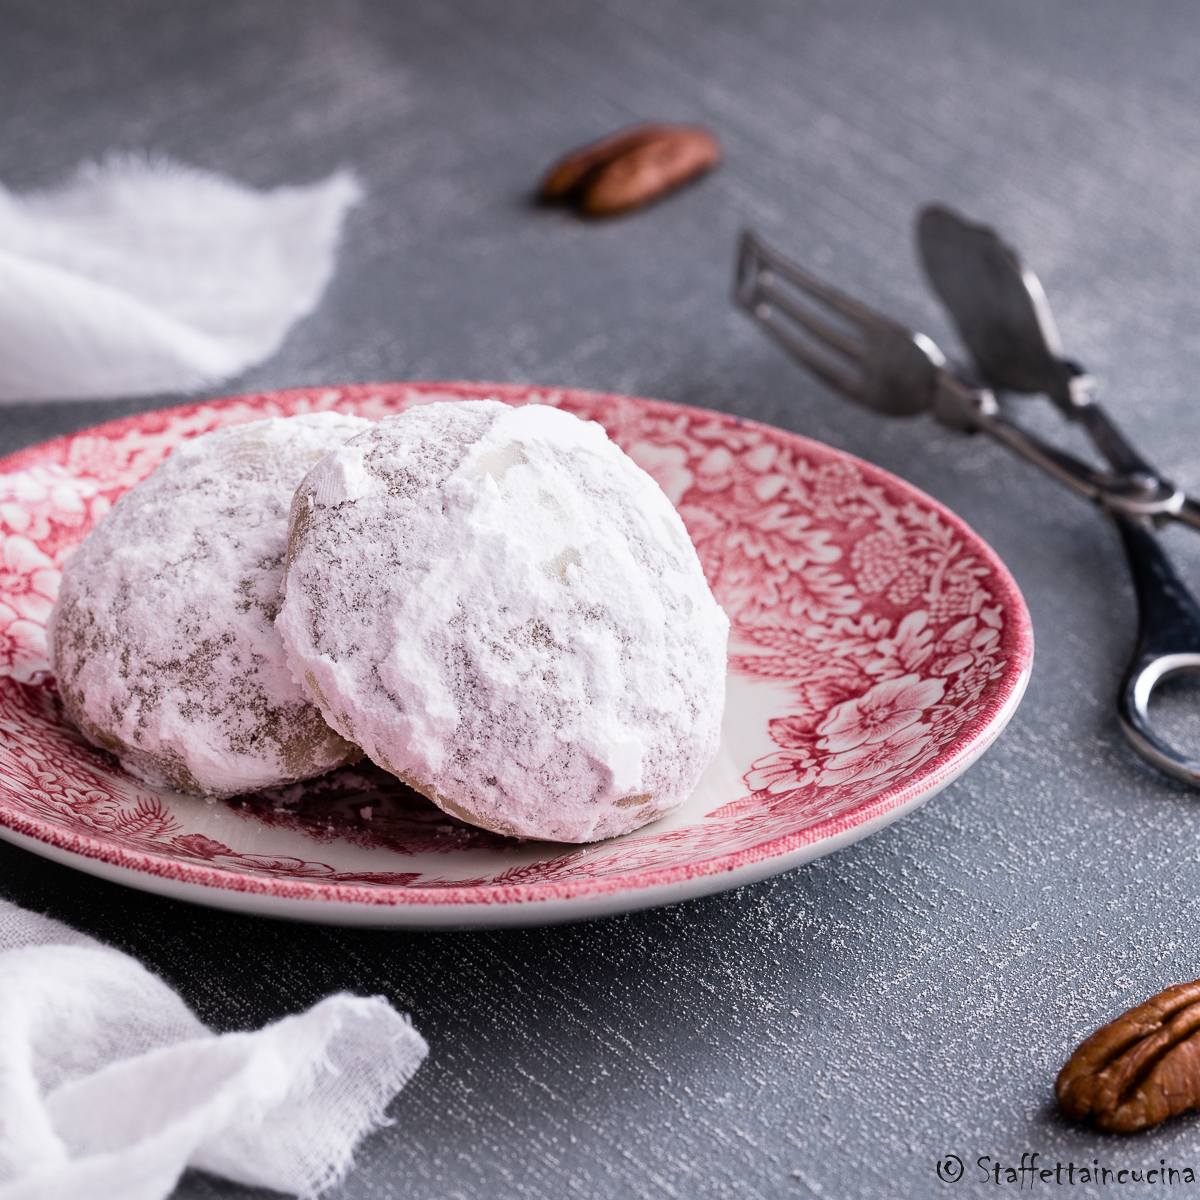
[{"x1": 0, "y1": 901, "x2": 427, "y2": 1200}]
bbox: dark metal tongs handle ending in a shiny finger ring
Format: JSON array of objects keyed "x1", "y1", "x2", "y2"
[{"x1": 1106, "y1": 509, "x2": 1200, "y2": 787}]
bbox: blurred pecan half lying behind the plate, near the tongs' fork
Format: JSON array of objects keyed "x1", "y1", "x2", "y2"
[{"x1": 538, "y1": 125, "x2": 721, "y2": 217}]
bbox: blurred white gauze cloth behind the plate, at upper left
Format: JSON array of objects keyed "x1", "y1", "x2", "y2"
[{"x1": 0, "y1": 156, "x2": 360, "y2": 401}]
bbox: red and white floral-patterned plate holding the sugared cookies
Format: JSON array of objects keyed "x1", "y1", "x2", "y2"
[{"x1": 0, "y1": 383, "x2": 1033, "y2": 928}]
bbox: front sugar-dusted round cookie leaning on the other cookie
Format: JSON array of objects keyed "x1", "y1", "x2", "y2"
[{"x1": 277, "y1": 401, "x2": 728, "y2": 841}]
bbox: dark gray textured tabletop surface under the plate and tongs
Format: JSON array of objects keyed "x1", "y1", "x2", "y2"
[{"x1": 0, "y1": 0, "x2": 1200, "y2": 1200}]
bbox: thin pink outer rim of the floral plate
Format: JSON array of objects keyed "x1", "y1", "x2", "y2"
[{"x1": 0, "y1": 380, "x2": 1033, "y2": 925}]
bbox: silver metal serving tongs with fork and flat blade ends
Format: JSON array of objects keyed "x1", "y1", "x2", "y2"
[{"x1": 734, "y1": 206, "x2": 1200, "y2": 787}]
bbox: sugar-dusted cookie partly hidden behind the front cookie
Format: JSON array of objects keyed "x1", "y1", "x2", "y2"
[{"x1": 50, "y1": 413, "x2": 371, "y2": 797}]
